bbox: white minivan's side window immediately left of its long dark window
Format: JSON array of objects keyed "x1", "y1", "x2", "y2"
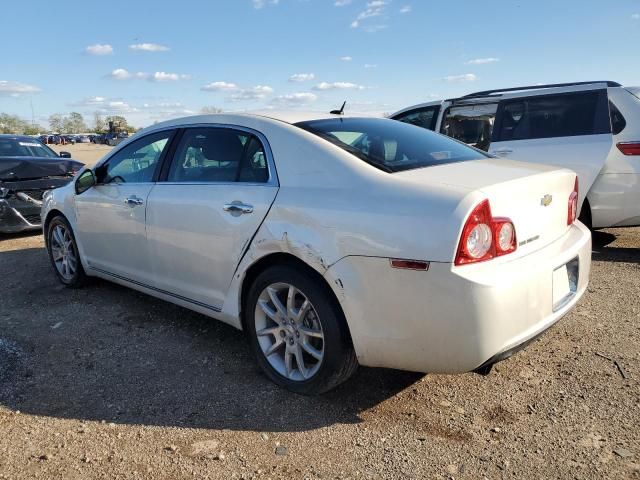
[{"x1": 440, "y1": 103, "x2": 498, "y2": 151}]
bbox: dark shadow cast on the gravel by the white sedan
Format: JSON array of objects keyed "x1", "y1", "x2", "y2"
[{"x1": 0, "y1": 248, "x2": 423, "y2": 432}]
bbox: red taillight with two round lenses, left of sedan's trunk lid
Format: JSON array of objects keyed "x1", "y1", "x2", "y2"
[{"x1": 455, "y1": 200, "x2": 516, "y2": 265}]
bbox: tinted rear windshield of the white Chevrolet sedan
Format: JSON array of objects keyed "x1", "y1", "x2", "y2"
[{"x1": 296, "y1": 118, "x2": 487, "y2": 173}]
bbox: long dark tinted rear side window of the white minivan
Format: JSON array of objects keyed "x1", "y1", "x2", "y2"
[{"x1": 493, "y1": 90, "x2": 611, "y2": 142}]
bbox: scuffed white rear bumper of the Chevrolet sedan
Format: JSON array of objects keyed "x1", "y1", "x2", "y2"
[{"x1": 327, "y1": 222, "x2": 591, "y2": 373}]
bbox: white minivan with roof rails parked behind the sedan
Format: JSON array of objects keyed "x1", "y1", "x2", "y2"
[{"x1": 391, "y1": 81, "x2": 640, "y2": 228}]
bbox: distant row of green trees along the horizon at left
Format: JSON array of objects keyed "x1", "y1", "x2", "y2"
[{"x1": 0, "y1": 112, "x2": 136, "y2": 135}]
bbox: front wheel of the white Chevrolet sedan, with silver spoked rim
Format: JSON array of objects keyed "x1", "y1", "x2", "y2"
[{"x1": 47, "y1": 215, "x2": 87, "y2": 288}]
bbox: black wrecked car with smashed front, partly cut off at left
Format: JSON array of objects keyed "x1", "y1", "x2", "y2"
[{"x1": 0, "y1": 135, "x2": 84, "y2": 233}]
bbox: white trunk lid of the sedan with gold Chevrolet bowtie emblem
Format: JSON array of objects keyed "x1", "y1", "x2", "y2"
[{"x1": 394, "y1": 159, "x2": 576, "y2": 259}]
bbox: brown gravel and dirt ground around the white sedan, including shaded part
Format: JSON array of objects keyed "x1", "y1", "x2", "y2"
[{"x1": 0, "y1": 227, "x2": 640, "y2": 479}]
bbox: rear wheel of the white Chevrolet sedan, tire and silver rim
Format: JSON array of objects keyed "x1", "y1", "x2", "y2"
[{"x1": 244, "y1": 265, "x2": 358, "y2": 395}]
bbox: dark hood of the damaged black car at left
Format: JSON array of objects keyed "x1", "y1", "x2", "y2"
[{"x1": 0, "y1": 157, "x2": 84, "y2": 182}]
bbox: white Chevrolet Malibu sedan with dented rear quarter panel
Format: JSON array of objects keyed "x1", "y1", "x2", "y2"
[{"x1": 42, "y1": 112, "x2": 591, "y2": 394}]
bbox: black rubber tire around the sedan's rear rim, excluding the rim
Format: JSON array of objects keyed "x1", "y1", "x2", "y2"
[{"x1": 243, "y1": 265, "x2": 352, "y2": 395}]
